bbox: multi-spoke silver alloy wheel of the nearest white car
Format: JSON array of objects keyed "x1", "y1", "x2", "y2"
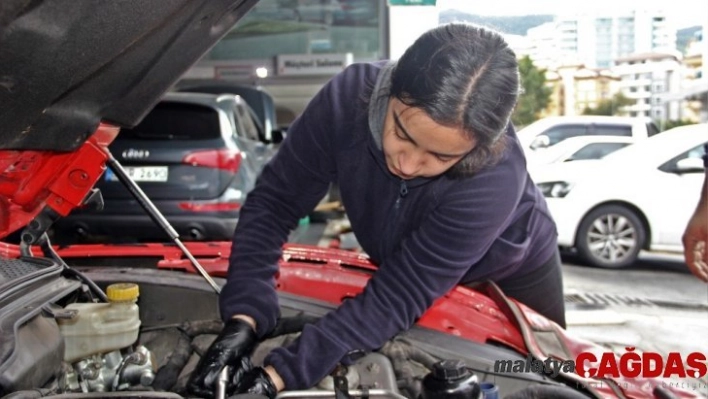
[{"x1": 576, "y1": 205, "x2": 646, "y2": 268}]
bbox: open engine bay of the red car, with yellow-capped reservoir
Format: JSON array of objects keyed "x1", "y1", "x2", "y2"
[{"x1": 0, "y1": 253, "x2": 586, "y2": 399}]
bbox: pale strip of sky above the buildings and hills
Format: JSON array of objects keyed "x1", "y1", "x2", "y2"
[{"x1": 437, "y1": 0, "x2": 708, "y2": 29}]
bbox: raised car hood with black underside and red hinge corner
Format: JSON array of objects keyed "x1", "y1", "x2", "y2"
[{"x1": 0, "y1": 0, "x2": 257, "y2": 238}]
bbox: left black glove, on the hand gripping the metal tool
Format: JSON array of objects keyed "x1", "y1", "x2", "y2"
[{"x1": 187, "y1": 319, "x2": 257, "y2": 398}]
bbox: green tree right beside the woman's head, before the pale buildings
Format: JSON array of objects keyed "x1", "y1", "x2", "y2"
[{"x1": 511, "y1": 56, "x2": 553, "y2": 126}]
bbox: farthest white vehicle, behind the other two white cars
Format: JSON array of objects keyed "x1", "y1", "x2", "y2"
[{"x1": 518, "y1": 115, "x2": 659, "y2": 154}]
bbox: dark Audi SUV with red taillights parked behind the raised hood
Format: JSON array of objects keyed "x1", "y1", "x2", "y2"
[{"x1": 55, "y1": 93, "x2": 276, "y2": 243}]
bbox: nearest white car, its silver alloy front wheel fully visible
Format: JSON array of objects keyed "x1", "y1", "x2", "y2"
[{"x1": 530, "y1": 124, "x2": 708, "y2": 268}]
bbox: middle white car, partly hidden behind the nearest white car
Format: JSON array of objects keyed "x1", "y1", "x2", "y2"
[{"x1": 526, "y1": 136, "x2": 638, "y2": 168}]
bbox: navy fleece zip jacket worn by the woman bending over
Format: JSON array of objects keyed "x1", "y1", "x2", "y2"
[{"x1": 220, "y1": 63, "x2": 556, "y2": 389}]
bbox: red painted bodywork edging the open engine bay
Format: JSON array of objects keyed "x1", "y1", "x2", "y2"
[{"x1": 0, "y1": 242, "x2": 701, "y2": 399}]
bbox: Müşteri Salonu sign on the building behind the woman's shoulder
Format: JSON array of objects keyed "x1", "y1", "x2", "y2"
[{"x1": 276, "y1": 53, "x2": 354, "y2": 76}]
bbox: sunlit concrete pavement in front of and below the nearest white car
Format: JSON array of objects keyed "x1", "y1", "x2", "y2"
[{"x1": 563, "y1": 255, "x2": 708, "y2": 397}]
